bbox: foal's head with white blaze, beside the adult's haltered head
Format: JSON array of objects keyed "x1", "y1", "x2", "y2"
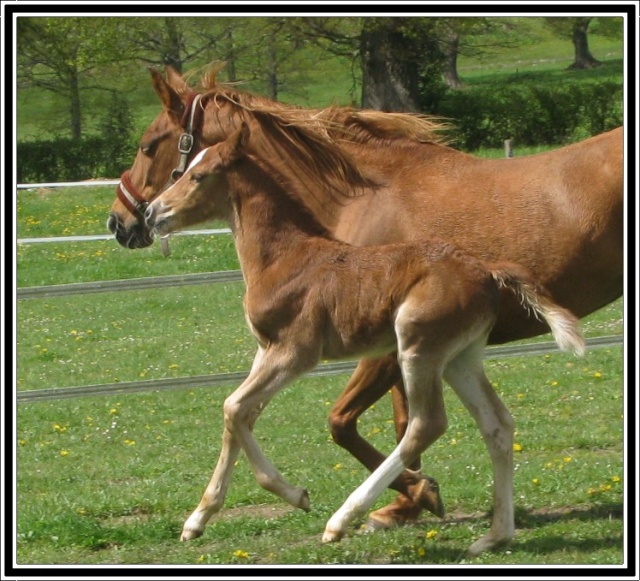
[{"x1": 145, "y1": 124, "x2": 249, "y2": 236}]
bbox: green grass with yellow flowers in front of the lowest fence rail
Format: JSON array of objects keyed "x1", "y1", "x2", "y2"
[{"x1": 17, "y1": 349, "x2": 625, "y2": 565}]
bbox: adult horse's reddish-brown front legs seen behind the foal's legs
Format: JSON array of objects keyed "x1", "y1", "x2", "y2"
[{"x1": 329, "y1": 354, "x2": 444, "y2": 529}]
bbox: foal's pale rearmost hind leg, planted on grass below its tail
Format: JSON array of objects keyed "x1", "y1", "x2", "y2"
[{"x1": 444, "y1": 343, "x2": 515, "y2": 556}]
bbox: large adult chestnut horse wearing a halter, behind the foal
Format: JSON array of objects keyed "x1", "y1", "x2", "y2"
[{"x1": 108, "y1": 63, "x2": 623, "y2": 526}]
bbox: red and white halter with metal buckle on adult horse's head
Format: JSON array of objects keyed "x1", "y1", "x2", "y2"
[{"x1": 116, "y1": 93, "x2": 203, "y2": 217}]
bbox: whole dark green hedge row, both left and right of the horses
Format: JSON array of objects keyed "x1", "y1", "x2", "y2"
[{"x1": 18, "y1": 82, "x2": 622, "y2": 183}]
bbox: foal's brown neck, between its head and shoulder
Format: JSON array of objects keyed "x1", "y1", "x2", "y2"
[{"x1": 226, "y1": 157, "x2": 331, "y2": 286}]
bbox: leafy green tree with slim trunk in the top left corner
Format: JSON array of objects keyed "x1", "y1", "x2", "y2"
[{"x1": 17, "y1": 17, "x2": 129, "y2": 139}]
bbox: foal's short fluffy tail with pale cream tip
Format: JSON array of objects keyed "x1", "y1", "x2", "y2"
[{"x1": 490, "y1": 263, "x2": 585, "y2": 355}]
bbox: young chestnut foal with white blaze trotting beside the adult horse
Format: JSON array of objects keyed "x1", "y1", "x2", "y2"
[{"x1": 145, "y1": 123, "x2": 584, "y2": 556}]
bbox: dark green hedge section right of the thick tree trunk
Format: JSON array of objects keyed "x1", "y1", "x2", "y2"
[{"x1": 437, "y1": 81, "x2": 623, "y2": 151}]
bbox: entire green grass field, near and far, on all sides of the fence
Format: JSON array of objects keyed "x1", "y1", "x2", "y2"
[{"x1": 14, "y1": 20, "x2": 636, "y2": 574}]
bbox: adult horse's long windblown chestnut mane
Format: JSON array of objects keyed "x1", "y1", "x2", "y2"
[{"x1": 179, "y1": 62, "x2": 448, "y2": 228}]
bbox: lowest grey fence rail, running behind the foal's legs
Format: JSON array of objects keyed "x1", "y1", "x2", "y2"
[{"x1": 16, "y1": 335, "x2": 624, "y2": 403}]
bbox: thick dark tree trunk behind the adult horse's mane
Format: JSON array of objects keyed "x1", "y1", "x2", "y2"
[{"x1": 360, "y1": 19, "x2": 420, "y2": 112}]
